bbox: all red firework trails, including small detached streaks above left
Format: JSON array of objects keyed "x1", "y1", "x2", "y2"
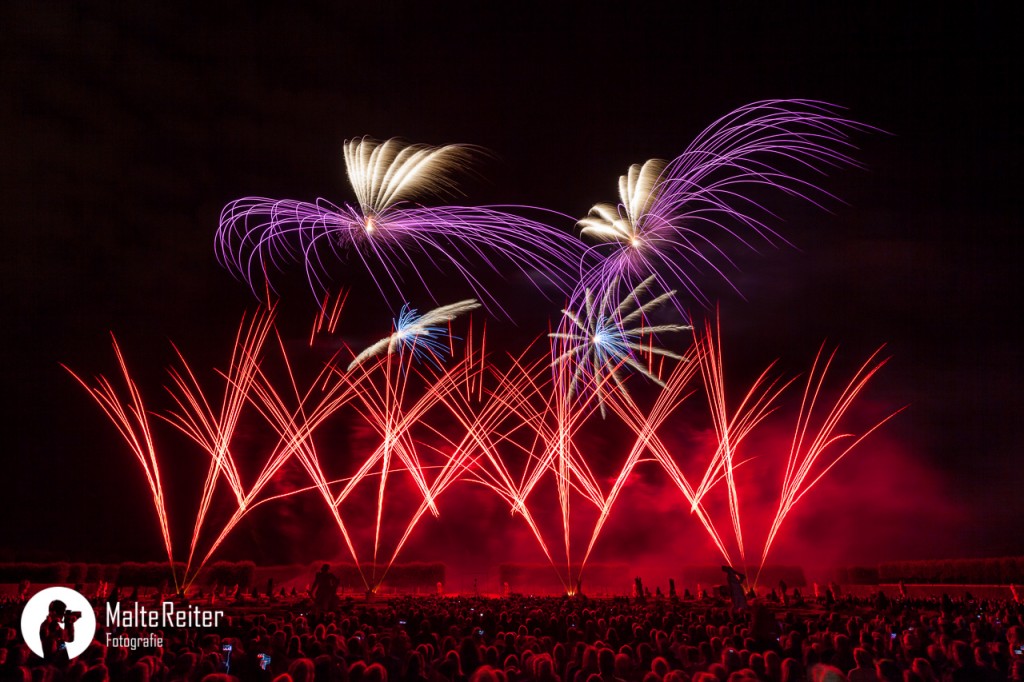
[{"x1": 66, "y1": 286, "x2": 899, "y2": 594}]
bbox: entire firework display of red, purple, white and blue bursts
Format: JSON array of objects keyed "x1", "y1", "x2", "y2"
[{"x1": 68, "y1": 100, "x2": 892, "y2": 594}]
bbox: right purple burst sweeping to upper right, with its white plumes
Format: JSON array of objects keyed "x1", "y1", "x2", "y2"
[{"x1": 580, "y1": 99, "x2": 874, "y2": 303}]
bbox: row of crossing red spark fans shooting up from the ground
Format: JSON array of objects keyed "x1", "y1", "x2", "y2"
[{"x1": 72, "y1": 310, "x2": 896, "y2": 592}]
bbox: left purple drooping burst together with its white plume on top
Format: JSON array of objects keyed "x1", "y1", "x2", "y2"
[{"x1": 215, "y1": 137, "x2": 587, "y2": 315}]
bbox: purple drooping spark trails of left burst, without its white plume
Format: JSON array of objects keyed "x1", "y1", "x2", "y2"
[{"x1": 226, "y1": 198, "x2": 595, "y2": 312}]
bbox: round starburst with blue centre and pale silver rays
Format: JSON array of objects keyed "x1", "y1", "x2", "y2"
[{"x1": 549, "y1": 276, "x2": 690, "y2": 415}]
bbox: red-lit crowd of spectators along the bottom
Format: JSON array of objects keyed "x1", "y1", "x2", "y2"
[{"x1": 0, "y1": 577, "x2": 1024, "y2": 682}]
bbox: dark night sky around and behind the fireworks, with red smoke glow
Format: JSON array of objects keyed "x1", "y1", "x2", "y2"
[{"x1": 0, "y1": 2, "x2": 1024, "y2": 563}]
